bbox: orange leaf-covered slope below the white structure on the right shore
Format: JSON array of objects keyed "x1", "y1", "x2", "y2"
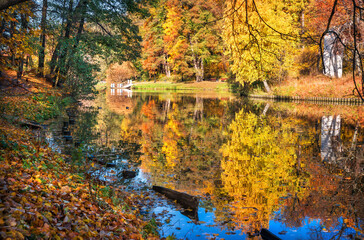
[{"x1": 253, "y1": 75, "x2": 357, "y2": 98}]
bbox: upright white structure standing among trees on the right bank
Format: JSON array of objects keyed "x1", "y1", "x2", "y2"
[{"x1": 323, "y1": 33, "x2": 343, "y2": 78}]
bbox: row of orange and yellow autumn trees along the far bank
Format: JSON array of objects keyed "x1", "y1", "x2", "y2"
[{"x1": 141, "y1": 0, "x2": 364, "y2": 98}]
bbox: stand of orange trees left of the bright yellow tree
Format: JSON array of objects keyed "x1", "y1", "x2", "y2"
[{"x1": 142, "y1": 0, "x2": 227, "y2": 81}]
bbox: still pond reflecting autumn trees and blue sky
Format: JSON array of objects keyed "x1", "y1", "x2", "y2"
[{"x1": 49, "y1": 91, "x2": 364, "y2": 239}]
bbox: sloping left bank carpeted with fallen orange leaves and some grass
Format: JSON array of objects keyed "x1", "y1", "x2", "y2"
[{"x1": 0, "y1": 72, "x2": 158, "y2": 239}]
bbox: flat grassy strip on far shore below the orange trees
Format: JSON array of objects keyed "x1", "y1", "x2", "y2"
[{"x1": 133, "y1": 81, "x2": 229, "y2": 92}]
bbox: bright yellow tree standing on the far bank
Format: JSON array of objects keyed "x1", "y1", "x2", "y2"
[{"x1": 224, "y1": 0, "x2": 304, "y2": 91}]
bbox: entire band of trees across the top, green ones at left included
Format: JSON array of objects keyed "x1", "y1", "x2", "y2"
[{"x1": 0, "y1": 0, "x2": 364, "y2": 98}]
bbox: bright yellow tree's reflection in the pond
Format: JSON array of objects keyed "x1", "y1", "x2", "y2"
[{"x1": 221, "y1": 110, "x2": 303, "y2": 232}]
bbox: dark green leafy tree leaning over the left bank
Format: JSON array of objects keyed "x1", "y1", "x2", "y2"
[{"x1": 45, "y1": 0, "x2": 141, "y2": 96}]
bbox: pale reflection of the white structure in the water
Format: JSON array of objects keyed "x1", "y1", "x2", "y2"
[{"x1": 321, "y1": 115, "x2": 342, "y2": 163}]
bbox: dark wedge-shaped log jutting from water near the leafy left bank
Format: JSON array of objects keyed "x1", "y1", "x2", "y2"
[{"x1": 153, "y1": 186, "x2": 198, "y2": 211}]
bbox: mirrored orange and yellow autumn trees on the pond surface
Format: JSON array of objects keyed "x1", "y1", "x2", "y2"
[{"x1": 97, "y1": 91, "x2": 364, "y2": 239}]
